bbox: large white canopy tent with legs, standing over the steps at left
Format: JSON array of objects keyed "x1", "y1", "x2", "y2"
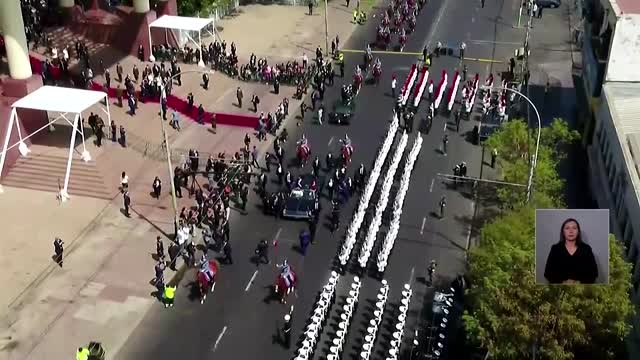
[{"x1": 0, "y1": 86, "x2": 111, "y2": 201}]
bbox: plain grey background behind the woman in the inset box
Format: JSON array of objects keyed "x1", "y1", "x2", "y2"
[{"x1": 536, "y1": 209, "x2": 609, "y2": 284}]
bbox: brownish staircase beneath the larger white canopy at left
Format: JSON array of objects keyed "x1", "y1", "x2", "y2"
[{"x1": 0, "y1": 154, "x2": 112, "y2": 200}]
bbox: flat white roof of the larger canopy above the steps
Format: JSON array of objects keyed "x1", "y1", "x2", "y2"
[{"x1": 11, "y1": 86, "x2": 107, "y2": 113}]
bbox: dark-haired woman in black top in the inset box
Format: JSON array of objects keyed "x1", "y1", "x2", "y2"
[{"x1": 544, "y1": 219, "x2": 598, "y2": 284}]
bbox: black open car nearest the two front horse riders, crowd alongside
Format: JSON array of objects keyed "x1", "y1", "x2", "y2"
[{"x1": 282, "y1": 174, "x2": 321, "y2": 219}]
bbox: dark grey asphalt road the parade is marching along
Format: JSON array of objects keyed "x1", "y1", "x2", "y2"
[{"x1": 114, "y1": 0, "x2": 517, "y2": 360}]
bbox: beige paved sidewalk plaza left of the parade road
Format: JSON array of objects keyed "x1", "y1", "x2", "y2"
[{"x1": 0, "y1": 2, "x2": 354, "y2": 360}]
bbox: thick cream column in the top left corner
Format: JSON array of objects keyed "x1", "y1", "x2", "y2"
[{"x1": 0, "y1": 1, "x2": 33, "y2": 80}]
